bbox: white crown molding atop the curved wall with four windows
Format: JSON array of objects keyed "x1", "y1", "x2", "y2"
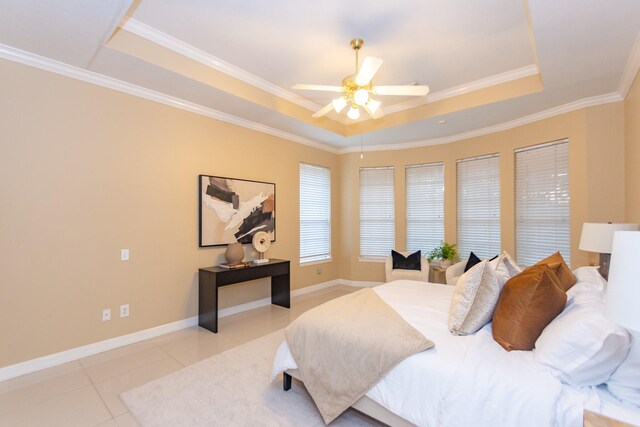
[{"x1": 339, "y1": 92, "x2": 624, "y2": 154}]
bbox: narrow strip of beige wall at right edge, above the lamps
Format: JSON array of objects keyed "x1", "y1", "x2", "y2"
[{"x1": 624, "y1": 73, "x2": 640, "y2": 223}]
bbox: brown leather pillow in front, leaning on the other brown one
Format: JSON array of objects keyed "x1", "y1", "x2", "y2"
[{"x1": 492, "y1": 264, "x2": 567, "y2": 351}]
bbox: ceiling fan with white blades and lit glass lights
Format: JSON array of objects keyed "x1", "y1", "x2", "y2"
[{"x1": 293, "y1": 39, "x2": 429, "y2": 120}]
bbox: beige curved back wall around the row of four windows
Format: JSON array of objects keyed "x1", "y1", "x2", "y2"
[{"x1": 340, "y1": 102, "x2": 625, "y2": 282}]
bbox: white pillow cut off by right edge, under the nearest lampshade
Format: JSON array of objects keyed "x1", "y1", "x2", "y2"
[{"x1": 607, "y1": 332, "x2": 640, "y2": 406}]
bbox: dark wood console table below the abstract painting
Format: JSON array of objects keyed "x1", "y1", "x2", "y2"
[{"x1": 198, "y1": 258, "x2": 291, "y2": 333}]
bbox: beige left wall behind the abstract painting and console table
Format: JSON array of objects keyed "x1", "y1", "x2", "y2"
[{"x1": 0, "y1": 61, "x2": 340, "y2": 367}]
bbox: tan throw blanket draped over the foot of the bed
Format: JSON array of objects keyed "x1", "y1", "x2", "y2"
[{"x1": 285, "y1": 288, "x2": 434, "y2": 424}]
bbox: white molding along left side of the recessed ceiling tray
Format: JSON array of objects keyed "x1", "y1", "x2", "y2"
[{"x1": 120, "y1": 18, "x2": 322, "y2": 112}]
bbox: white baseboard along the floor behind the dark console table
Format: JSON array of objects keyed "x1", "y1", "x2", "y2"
[{"x1": 0, "y1": 279, "x2": 350, "y2": 381}]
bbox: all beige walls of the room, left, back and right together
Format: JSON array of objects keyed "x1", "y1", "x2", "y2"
[{"x1": 0, "y1": 55, "x2": 640, "y2": 367}]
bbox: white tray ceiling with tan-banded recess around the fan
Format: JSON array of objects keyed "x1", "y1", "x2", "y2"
[{"x1": 0, "y1": 0, "x2": 640, "y2": 151}]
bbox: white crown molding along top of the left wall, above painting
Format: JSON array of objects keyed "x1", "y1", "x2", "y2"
[{"x1": 0, "y1": 43, "x2": 338, "y2": 153}]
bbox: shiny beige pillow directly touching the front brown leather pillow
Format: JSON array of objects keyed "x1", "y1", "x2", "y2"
[{"x1": 449, "y1": 260, "x2": 502, "y2": 335}]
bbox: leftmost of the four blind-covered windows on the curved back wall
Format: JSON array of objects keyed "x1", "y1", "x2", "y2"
[{"x1": 360, "y1": 167, "x2": 395, "y2": 258}]
